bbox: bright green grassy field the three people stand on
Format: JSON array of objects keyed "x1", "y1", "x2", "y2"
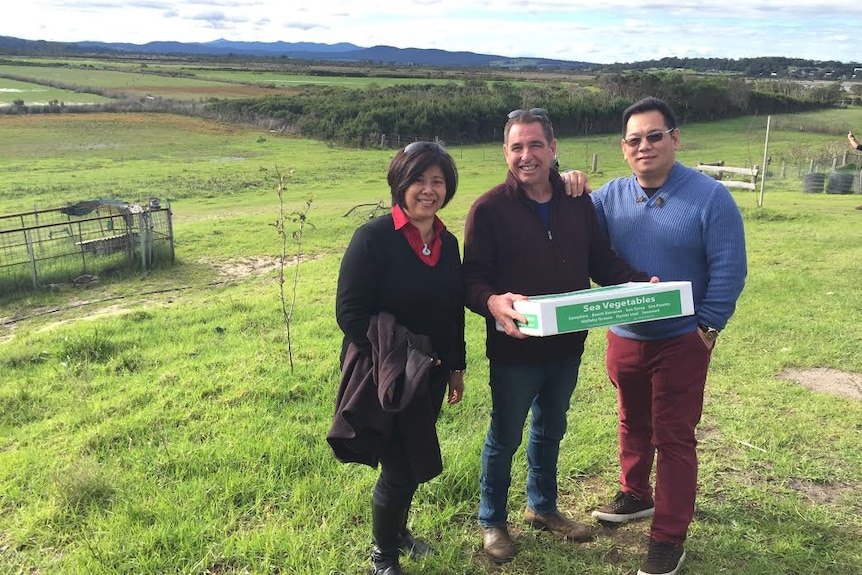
[{"x1": 0, "y1": 110, "x2": 862, "y2": 575}]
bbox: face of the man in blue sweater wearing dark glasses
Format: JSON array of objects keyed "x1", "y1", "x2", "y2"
[{"x1": 622, "y1": 110, "x2": 679, "y2": 188}]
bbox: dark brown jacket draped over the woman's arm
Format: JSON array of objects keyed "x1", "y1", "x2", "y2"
[{"x1": 326, "y1": 312, "x2": 443, "y2": 483}]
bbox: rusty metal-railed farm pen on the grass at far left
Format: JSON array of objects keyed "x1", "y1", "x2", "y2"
[{"x1": 0, "y1": 198, "x2": 174, "y2": 295}]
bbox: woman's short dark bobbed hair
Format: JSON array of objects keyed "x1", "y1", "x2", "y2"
[{"x1": 387, "y1": 142, "x2": 458, "y2": 208}]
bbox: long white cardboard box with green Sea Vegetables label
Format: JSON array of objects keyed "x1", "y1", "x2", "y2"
[{"x1": 506, "y1": 282, "x2": 694, "y2": 336}]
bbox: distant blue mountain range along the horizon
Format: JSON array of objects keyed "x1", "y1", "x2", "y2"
[{"x1": 0, "y1": 36, "x2": 595, "y2": 70}]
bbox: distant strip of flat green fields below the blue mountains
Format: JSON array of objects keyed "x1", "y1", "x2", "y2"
[{"x1": 0, "y1": 57, "x2": 594, "y2": 105}]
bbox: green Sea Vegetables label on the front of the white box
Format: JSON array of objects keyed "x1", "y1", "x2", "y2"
[{"x1": 556, "y1": 290, "x2": 682, "y2": 332}]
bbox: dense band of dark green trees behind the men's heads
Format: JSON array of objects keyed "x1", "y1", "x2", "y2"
[{"x1": 207, "y1": 73, "x2": 836, "y2": 147}]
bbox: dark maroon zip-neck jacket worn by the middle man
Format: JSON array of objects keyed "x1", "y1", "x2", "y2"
[{"x1": 463, "y1": 171, "x2": 649, "y2": 363}]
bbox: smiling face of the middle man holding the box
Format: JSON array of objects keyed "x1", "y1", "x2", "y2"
[{"x1": 503, "y1": 122, "x2": 557, "y2": 199}]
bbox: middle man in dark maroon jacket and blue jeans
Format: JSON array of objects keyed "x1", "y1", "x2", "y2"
[{"x1": 463, "y1": 108, "x2": 649, "y2": 562}]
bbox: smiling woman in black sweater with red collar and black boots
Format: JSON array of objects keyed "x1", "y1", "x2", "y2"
[{"x1": 328, "y1": 142, "x2": 466, "y2": 575}]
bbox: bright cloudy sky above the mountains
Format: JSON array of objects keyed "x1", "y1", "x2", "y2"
[{"x1": 6, "y1": 0, "x2": 862, "y2": 63}]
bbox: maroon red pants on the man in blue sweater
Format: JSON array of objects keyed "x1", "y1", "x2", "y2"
[{"x1": 606, "y1": 331, "x2": 712, "y2": 543}]
